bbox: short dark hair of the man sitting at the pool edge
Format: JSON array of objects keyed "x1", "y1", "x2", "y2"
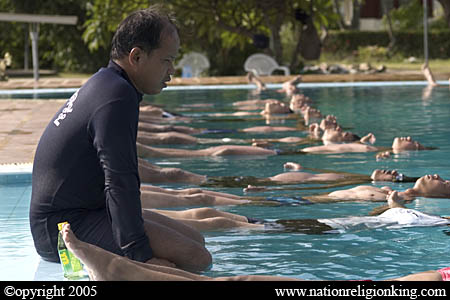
[{"x1": 110, "y1": 5, "x2": 177, "y2": 59}]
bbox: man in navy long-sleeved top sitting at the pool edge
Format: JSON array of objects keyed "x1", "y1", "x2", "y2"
[{"x1": 30, "y1": 6, "x2": 212, "y2": 271}]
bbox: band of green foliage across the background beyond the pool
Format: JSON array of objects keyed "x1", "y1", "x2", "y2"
[{"x1": 7, "y1": 0, "x2": 436, "y2": 75}]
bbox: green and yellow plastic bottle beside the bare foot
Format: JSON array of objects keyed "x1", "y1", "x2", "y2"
[{"x1": 58, "y1": 222, "x2": 89, "y2": 280}]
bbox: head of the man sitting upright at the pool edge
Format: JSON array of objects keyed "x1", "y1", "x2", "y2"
[{"x1": 110, "y1": 6, "x2": 180, "y2": 94}]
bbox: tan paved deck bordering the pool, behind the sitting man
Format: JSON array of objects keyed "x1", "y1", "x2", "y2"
[{"x1": 0, "y1": 71, "x2": 442, "y2": 169}]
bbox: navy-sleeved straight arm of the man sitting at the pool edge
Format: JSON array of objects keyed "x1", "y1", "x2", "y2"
[{"x1": 88, "y1": 99, "x2": 152, "y2": 262}]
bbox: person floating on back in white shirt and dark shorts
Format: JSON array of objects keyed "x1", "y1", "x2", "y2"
[{"x1": 148, "y1": 191, "x2": 450, "y2": 234}]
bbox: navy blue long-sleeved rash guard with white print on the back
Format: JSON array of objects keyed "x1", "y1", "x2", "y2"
[{"x1": 30, "y1": 61, "x2": 152, "y2": 262}]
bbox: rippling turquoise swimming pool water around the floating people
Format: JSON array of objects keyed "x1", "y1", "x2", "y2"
[{"x1": 0, "y1": 83, "x2": 450, "y2": 280}]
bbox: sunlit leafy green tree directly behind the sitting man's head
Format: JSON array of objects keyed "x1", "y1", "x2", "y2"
[{"x1": 83, "y1": 0, "x2": 337, "y2": 73}]
